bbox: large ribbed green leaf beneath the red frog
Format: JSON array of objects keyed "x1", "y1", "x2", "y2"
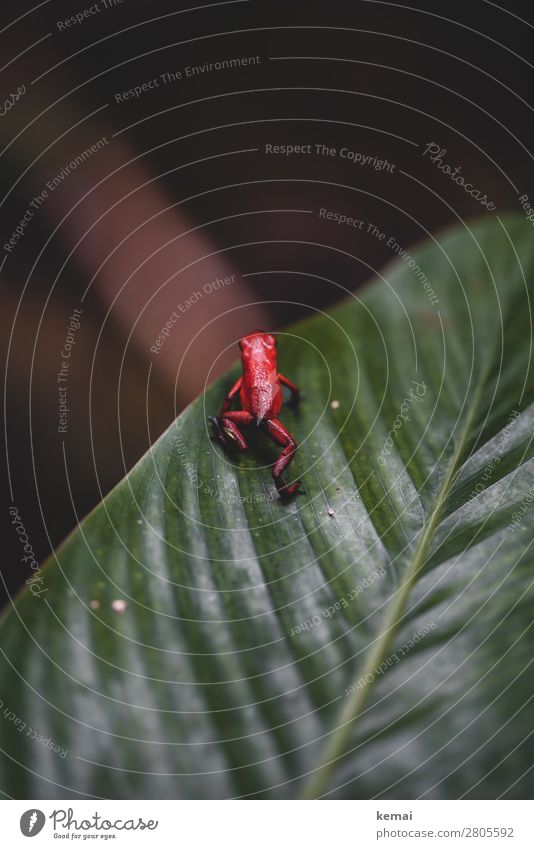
[{"x1": 0, "y1": 216, "x2": 534, "y2": 798}]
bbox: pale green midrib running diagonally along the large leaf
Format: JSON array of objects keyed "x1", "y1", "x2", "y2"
[{"x1": 299, "y1": 357, "x2": 493, "y2": 799}]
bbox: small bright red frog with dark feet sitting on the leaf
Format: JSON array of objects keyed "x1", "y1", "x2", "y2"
[{"x1": 211, "y1": 330, "x2": 300, "y2": 500}]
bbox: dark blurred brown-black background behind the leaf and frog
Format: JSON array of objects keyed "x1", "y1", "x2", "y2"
[{"x1": 0, "y1": 0, "x2": 534, "y2": 599}]
